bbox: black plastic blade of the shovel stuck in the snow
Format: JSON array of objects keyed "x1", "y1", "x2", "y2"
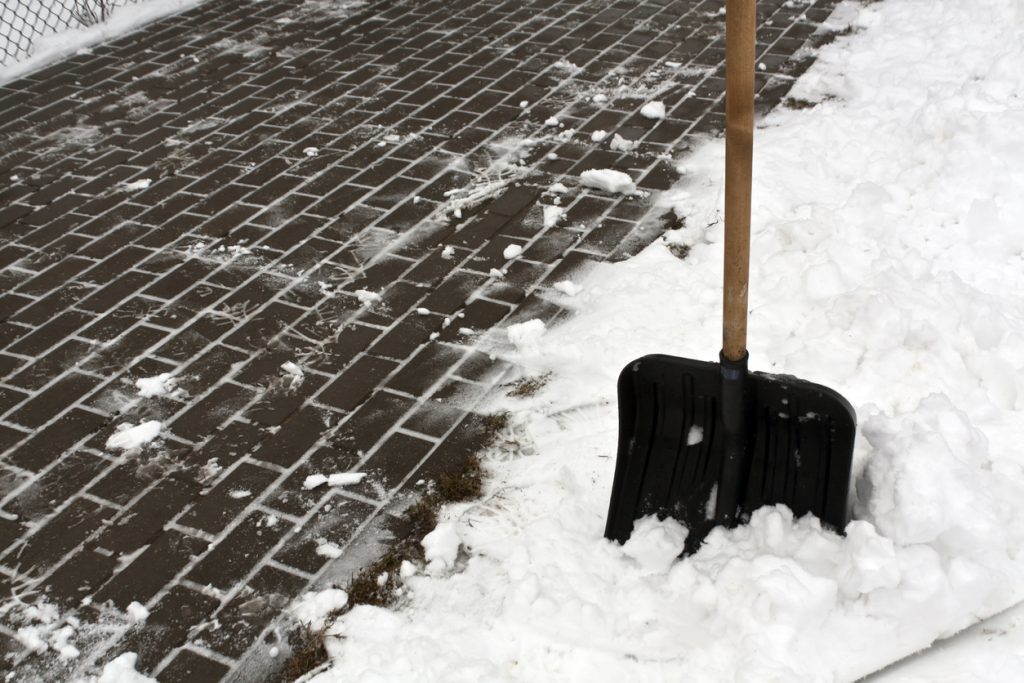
[{"x1": 604, "y1": 355, "x2": 856, "y2": 553}]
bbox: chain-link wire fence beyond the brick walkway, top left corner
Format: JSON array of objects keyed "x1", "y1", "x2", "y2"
[{"x1": 0, "y1": 0, "x2": 144, "y2": 67}]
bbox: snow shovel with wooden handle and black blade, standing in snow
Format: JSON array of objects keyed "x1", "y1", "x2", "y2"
[{"x1": 604, "y1": 0, "x2": 856, "y2": 553}]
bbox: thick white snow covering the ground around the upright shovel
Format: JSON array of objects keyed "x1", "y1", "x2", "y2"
[{"x1": 292, "y1": 0, "x2": 1024, "y2": 683}]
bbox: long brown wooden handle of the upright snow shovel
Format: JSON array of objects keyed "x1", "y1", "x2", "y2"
[{"x1": 722, "y1": 0, "x2": 757, "y2": 360}]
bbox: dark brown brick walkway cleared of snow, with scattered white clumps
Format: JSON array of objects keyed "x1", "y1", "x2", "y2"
[{"x1": 0, "y1": 0, "x2": 833, "y2": 682}]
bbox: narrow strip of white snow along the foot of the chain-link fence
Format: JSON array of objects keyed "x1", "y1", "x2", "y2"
[{"x1": 0, "y1": 0, "x2": 202, "y2": 84}]
